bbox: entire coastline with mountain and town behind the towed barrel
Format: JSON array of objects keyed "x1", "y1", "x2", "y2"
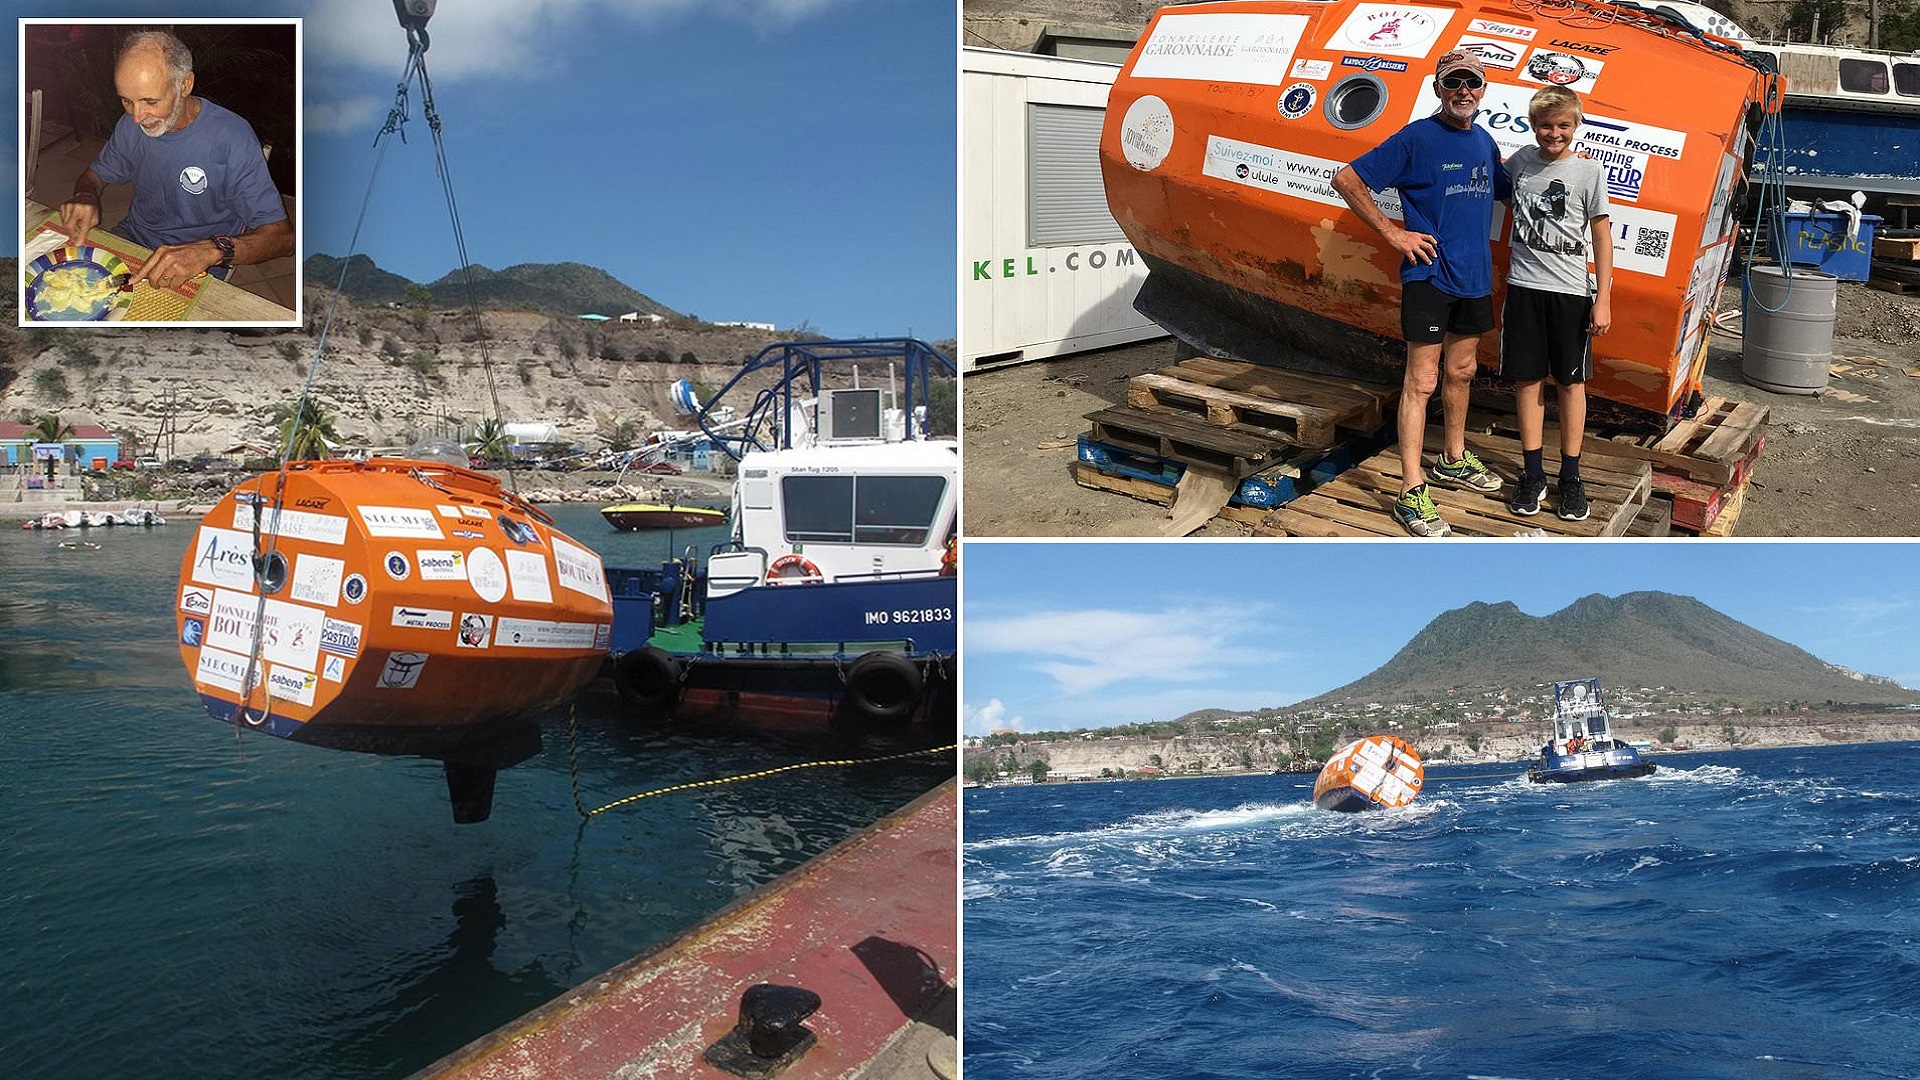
[{"x1": 966, "y1": 592, "x2": 1920, "y2": 778}]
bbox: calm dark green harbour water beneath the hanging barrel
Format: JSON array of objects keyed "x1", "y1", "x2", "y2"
[{"x1": 0, "y1": 507, "x2": 952, "y2": 1080}]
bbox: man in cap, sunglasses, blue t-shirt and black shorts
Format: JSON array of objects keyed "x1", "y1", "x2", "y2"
[{"x1": 1332, "y1": 50, "x2": 1511, "y2": 536}]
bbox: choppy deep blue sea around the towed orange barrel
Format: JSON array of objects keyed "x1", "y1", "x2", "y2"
[{"x1": 962, "y1": 744, "x2": 1920, "y2": 1080}]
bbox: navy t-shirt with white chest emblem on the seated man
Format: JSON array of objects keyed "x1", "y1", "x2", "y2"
[{"x1": 94, "y1": 98, "x2": 286, "y2": 248}]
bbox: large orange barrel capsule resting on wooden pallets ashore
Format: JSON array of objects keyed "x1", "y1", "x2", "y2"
[{"x1": 1100, "y1": 0, "x2": 1784, "y2": 419}]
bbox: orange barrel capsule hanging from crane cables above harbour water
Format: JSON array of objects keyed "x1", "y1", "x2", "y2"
[{"x1": 177, "y1": 457, "x2": 612, "y2": 763}]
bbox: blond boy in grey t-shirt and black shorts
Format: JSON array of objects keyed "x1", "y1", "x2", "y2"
[{"x1": 1500, "y1": 86, "x2": 1613, "y2": 521}]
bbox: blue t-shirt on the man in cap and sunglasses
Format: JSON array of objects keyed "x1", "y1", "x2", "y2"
[{"x1": 1354, "y1": 115, "x2": 1511, "y2": 296}]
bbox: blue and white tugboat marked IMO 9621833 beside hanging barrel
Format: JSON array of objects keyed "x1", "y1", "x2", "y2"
[{"x1": 607, "y1": 338, "x2": 960, "y2": 730}]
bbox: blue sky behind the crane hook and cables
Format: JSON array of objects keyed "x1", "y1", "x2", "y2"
[{"x1": 8, "y1": 0, "x2": 958, "y2": 340}]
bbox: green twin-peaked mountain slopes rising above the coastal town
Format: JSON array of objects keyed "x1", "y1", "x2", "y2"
[{"x1": 1306, "y1": 592, "x2": 1920, "y2": 705}]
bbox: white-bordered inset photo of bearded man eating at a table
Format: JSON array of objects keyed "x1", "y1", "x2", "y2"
[{"x1": 17, "y1": 19, "x2": 303, "y2": 327}]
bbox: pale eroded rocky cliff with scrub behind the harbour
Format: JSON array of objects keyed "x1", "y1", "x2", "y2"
[{"x1": 0, "y1": 259, "x2": 950, "y2": 457}]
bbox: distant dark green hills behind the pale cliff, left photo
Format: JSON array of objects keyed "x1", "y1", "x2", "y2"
[{"x1": 303, "y1": 256, "x2": 680, "y2": 319}]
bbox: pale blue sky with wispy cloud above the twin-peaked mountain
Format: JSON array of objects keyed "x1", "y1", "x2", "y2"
[{"x1": 960, "y1": 540, "x2": 1920, "y2": 734}]
